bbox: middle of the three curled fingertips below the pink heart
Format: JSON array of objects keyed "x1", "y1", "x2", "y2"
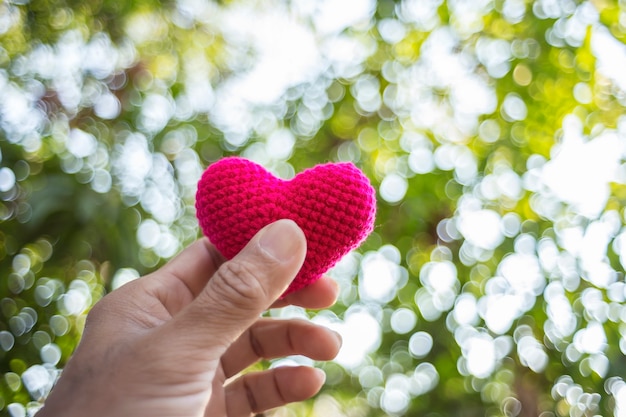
[{"x1": 222, "y1": 319, "x2": 341, "y2": 378}]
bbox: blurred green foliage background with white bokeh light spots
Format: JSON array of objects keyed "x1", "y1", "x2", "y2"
[{"x1": 0, "y1": 0, "x2": 626, "y2": 417}]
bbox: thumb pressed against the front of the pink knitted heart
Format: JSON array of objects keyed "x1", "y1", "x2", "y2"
[{"x1": 172, "y1": 220, "x2": 306, "y2": 349}]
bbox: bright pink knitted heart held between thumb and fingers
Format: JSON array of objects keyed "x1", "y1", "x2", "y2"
[{"x1": 196, "y1": 157, "x2": 376, "y2": 294}]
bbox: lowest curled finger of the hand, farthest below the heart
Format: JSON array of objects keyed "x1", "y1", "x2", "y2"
[{"x1": 226, "y1": 366, "x2": 326, "y2": 417}]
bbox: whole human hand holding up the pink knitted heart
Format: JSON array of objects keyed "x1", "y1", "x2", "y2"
[{"x1": 37, "y1": 220, "x2": 341, "y2": 417}]
